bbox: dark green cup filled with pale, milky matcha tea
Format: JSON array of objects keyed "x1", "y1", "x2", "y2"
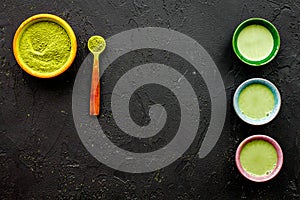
[{"x1": 232, "y1": 18, "x2": 280, "y2": 66}]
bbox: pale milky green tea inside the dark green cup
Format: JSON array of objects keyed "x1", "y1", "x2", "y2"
[{"x1": 237, "y1": 25, "x2": 274, "y2": 61}]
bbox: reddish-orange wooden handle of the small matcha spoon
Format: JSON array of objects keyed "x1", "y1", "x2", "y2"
[{"x1": 90, "y1": 55, "x2": 100, "y2": 115}]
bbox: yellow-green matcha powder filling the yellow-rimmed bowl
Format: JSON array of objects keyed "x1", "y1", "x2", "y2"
[{"x1": 19, "y1": 21, "x2": 71, "y2": 73}]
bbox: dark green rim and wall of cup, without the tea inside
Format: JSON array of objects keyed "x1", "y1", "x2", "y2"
[{"x1": 232, "y1": 17, "x2": 280, "y2": 66}]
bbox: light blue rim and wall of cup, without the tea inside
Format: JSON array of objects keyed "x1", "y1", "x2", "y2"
[{"x1": 233, "y1": 78, "x2": 281, "y2": 125}]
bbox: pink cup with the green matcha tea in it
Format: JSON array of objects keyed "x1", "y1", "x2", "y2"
[{"x1": 235, "y1": 135, "x2": 283, "y2": 182}]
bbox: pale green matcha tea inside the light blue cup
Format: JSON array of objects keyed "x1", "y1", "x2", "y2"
[{"x1": 238, "y1": 83, "x2": 275, "y2": 119}]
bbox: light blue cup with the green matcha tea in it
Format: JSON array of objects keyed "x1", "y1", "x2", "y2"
[{"x1": 233, "y1": 78, "x2": 281, "y2": 125}]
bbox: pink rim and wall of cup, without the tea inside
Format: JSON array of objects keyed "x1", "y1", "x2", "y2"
[{"x1": 235, "y1": 135, "x2": 283, "y2": 182}]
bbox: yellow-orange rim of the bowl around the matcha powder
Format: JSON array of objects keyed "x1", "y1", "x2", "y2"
[{"x1": 13, "y1": 13, "x2": 77, "y2": 78}]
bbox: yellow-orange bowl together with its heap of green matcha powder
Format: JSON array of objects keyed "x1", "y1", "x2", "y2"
[{"x1": 13, "y1": 14, "x2": 77, "y2": 78}]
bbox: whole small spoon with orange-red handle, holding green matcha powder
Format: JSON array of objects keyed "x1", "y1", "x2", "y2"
[{"x1": 88, "y1": 35, "x2": 106, "y2": 115}]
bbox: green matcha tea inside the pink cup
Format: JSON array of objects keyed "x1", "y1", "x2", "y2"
[{"x1": 240, "y1": 140, "x2": 277, "y2": 176}]
